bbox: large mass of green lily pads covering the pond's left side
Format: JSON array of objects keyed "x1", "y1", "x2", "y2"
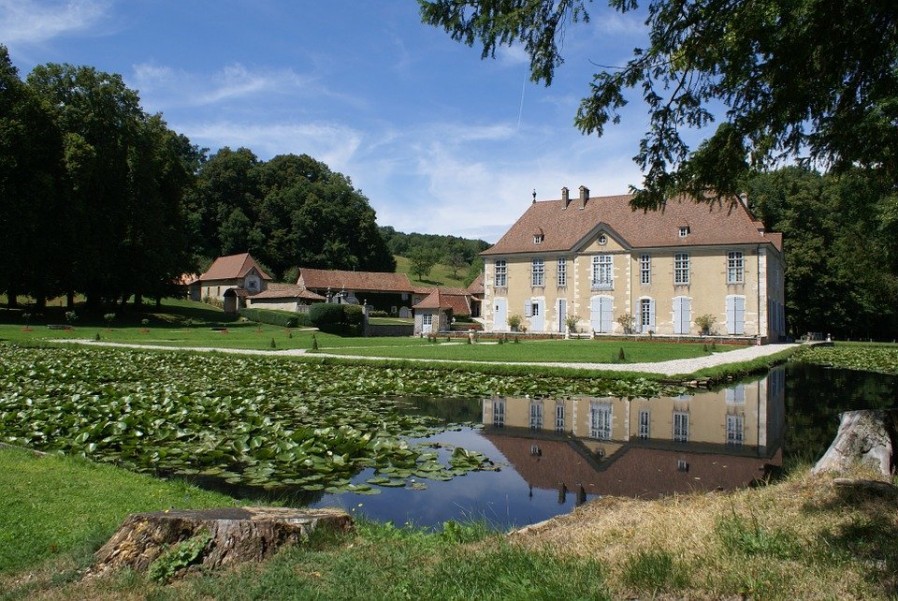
[{"x1": 0, "y1": 345, "x2": 672, "y2": 493}]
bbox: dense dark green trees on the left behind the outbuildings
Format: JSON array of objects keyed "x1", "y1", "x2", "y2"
[{"x1": 0, "y1": 46, "x2": 395, "y2": 307}]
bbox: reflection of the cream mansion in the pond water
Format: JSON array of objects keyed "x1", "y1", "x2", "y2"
[{"x1": 483, "y1": 368, "x2": 785, "y2": 502}]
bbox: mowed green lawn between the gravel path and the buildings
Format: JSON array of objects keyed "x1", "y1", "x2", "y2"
[{"x1": 0, "y1": 299, "x2": 735, "y2": 363}]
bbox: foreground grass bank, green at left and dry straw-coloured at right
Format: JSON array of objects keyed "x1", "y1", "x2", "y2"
[{"x1": 0, "y1": 449, "x2": 898, "y2": 601}]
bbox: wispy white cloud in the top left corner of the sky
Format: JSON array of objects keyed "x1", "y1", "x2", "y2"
[{"x1": 0, "y1": 0, "x2": 110, "y2": 44}]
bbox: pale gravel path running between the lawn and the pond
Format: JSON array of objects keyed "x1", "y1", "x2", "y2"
[{"x1": 55, "y1": 339, "x2": 798, "y2": 376}]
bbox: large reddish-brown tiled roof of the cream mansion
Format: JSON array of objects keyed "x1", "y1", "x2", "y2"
[{"x1": 482, "y1": 195, "x2": 783, "y2": 255}]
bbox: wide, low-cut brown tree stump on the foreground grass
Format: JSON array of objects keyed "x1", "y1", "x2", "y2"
[{"x1": 91, "y1": 507, "x2": 353, "y2": 573}]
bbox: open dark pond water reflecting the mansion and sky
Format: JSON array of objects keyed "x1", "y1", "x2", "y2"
[{"x1": 207, "y1": 364, "x2": 898, "y2": 528}]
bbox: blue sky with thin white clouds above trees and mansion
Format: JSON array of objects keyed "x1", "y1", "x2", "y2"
[{"x1": 0, "y1": 0, "x2": 647, "y2": 242}]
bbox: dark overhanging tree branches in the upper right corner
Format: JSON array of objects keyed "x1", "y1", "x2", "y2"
[{"x1": 419, "y1": 0, "x2": 898, "y2": 208}]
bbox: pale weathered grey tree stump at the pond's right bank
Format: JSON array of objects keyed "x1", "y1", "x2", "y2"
[{"x1": 812, "y1": 409, "x2": 898, "y2": 476}]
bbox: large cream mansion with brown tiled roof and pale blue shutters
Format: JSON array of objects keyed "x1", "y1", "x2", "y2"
[{"x1": 483, "y1": 191, "x2": 785, "y2": 342}]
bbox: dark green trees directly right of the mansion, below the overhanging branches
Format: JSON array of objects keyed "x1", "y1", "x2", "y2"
[{"x1": 747, "y1": 167, "x2": 898, "y2": 339}]
